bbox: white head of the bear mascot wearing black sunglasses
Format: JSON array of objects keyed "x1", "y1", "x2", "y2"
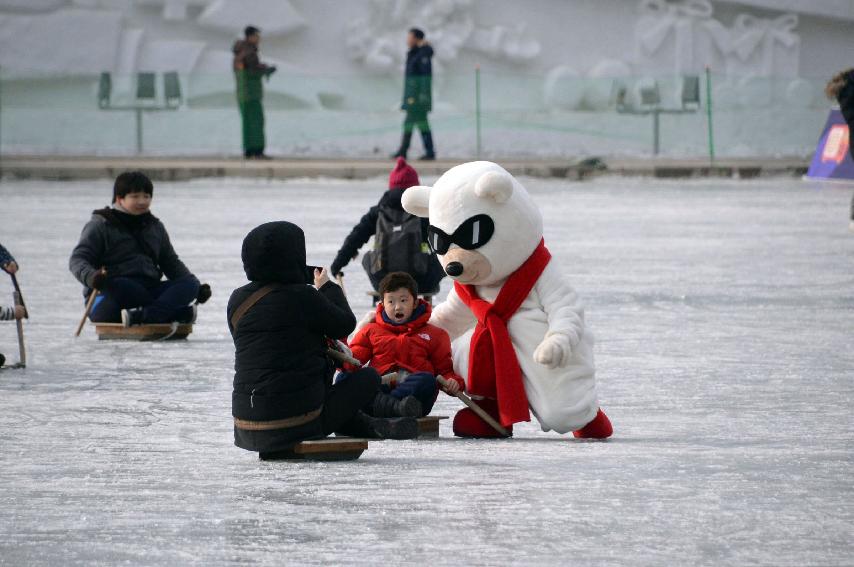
[{"x1": 402, "y1": 161, "x2": 543, "y2": 285}]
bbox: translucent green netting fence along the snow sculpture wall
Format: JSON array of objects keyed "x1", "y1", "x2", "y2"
[{"x1": 0, "y1": 69, "x2": 829, "y2": 157}]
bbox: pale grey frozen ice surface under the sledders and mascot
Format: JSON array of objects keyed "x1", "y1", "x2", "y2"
[{"x1": 0, "y1": 178, "x2": 854, "y2": 565}]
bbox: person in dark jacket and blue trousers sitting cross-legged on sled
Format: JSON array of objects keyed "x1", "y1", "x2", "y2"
[{"x1": 69, "y1": 171, "x2": 211, "y2": 327}]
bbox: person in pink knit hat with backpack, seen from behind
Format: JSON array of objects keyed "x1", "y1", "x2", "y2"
[{"x1": 330, "y1": 158, "x2": 445, "y2": 294}]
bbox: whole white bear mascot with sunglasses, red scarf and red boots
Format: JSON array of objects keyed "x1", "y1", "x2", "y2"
[{"x1": 403, "y1": 161, "x2": 612, "y2": 439}]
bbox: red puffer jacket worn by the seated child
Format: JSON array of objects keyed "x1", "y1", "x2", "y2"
[{"x1": 350, "y1": 299, "x2": 466, "y2": 390}]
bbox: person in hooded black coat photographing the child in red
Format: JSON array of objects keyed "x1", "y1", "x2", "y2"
[{"x1": 228, "y1": 221, "x2": 418, "y2": 458}]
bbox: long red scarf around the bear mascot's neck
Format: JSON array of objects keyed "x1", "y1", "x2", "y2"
[{"x1": 454, "y1": 240, "x2": 552, "y2": 427}]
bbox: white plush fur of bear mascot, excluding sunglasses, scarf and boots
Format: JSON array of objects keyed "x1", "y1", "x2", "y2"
[{"x1": 403, "y1": 161, "x2": 599, "y2": 433}]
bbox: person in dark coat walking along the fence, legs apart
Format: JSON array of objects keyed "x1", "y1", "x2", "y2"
[{"x1": 392, "y1": 28, "x2": 436, "y2": 160}]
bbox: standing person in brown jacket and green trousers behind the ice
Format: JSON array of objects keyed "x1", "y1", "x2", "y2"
[{"x1": 232, "y1": 26, "x2": 276, "y2": 159}]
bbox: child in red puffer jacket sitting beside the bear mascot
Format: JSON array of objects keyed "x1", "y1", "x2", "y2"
[{"x1": 350, "y1": 272, "x2": 465, "y2": 417}]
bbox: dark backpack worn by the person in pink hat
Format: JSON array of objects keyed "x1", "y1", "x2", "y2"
[{"x1": 371, "y1": 207, "x2": 430, "y2": 276}]
